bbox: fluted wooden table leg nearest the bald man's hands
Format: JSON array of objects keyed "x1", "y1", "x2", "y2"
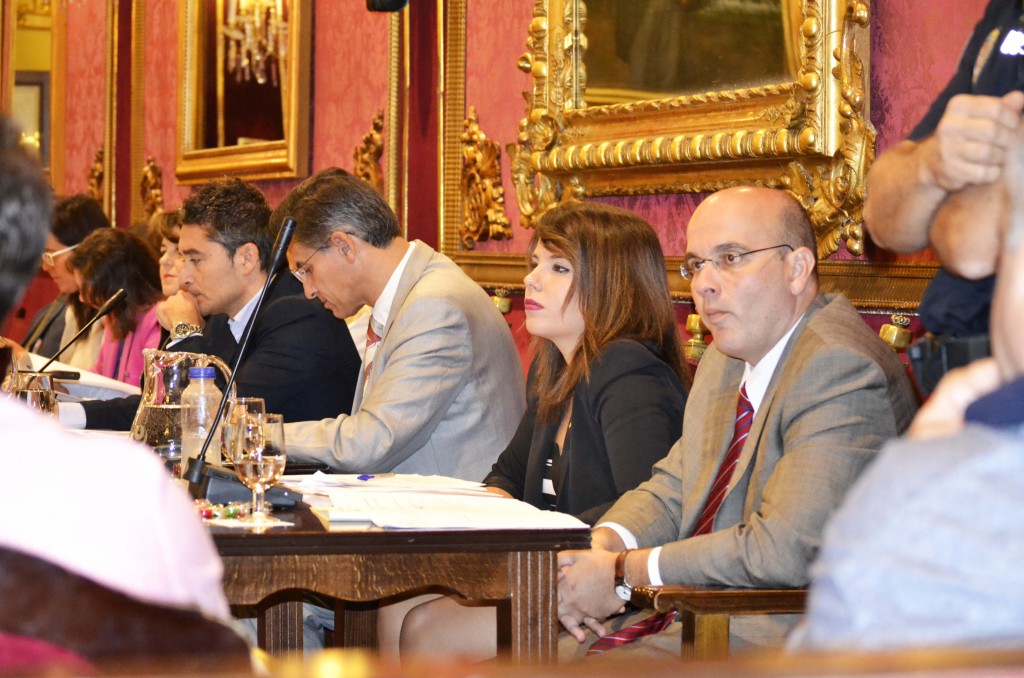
[{"x1": 499, "y1": 551, "x2": 558, "y2": 664}]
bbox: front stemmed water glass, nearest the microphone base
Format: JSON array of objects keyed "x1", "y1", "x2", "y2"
[{"x1": 231, "y1": 413, "x2": 286, "y2": 522}]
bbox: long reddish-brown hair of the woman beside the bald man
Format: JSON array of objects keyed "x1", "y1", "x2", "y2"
[{"x1": 529, "y1": 202, "x2": 691, "y2": 422}]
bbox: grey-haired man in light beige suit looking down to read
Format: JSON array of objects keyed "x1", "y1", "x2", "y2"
[{"x1": 285, "y1": 169, "x2": 525, "y2": 480}]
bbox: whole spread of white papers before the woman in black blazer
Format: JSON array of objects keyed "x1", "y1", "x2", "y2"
[{"x1": 293, "y1": 473, "x2": 587, "y2": 529}]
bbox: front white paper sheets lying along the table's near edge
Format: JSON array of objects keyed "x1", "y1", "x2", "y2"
[{"x1": 311, "y1": 488, "x2": 587, "y2": 529}]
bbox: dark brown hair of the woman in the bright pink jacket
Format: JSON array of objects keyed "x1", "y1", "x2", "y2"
[{"x1": 69, "y1": 228, "x2": 163, "y2": 340}]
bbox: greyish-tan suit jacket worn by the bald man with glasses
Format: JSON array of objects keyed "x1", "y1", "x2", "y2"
[{"x1": 604, "y1": 323, "x2": 909, "y2": 587}]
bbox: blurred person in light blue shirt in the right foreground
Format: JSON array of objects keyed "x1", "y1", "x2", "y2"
[{"x1": 791, "y1": 124, "x2": 1024, "y2": 650}]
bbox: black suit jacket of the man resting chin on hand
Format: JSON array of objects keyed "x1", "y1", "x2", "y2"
[{"x1": 82, "y1": 274, "x2": 360, "y2": 431}]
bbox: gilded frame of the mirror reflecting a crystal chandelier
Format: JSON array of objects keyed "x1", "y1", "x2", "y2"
[{"x1": 175, "y1": 0, "x2": 313, "y2": 183}]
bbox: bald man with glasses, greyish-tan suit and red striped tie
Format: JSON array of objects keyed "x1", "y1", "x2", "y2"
[{"x1": 559, "y1": 187, "x2": 916, "y2": 656}]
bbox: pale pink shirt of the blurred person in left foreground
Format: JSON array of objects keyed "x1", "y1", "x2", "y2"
[{"x1": 0, "y1": 398, "x2": 230, "y2": 622}]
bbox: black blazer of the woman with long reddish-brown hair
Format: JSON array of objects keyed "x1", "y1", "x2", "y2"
[{"x1": 483, "y1": 339, "x2": 687, "y2": 524}]
